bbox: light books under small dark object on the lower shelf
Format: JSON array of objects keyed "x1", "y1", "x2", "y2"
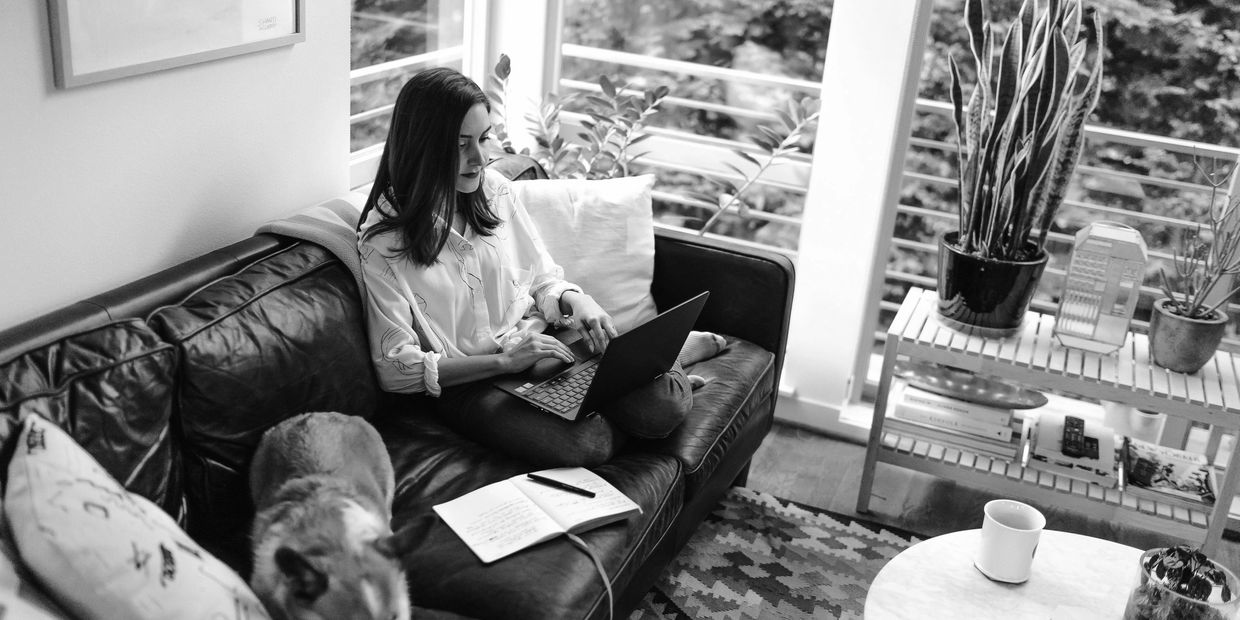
[{"x1": 1024, "y1": 410, "x2": 1117, "y2": 489}]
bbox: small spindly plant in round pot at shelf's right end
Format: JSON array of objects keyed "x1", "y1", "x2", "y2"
[{"x1": 1149, "y1": 155, "x2": 1240, "y2": 373}]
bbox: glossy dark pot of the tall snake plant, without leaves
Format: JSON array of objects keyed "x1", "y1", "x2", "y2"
[{"x1": 939, "y1": 231, "x2": 1048, "y2": 336}]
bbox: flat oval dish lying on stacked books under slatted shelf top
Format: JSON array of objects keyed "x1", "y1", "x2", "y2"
[{"x1": 895, "y1": 360, "x2": 1047, "y2": 409}]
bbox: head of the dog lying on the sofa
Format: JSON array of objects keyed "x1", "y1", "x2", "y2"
[{"x1": 258, "y1": 536, "x2": 410, "y2": 620}]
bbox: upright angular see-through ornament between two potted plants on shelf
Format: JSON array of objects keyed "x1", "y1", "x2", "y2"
[{"x1": 1054, "y1": 222, "x2": 1147, "y2": 353}]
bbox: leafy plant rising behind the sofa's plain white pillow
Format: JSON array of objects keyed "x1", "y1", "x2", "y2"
[{"x1": 486, "y1": 55, "x2": 820, "y2": 234}]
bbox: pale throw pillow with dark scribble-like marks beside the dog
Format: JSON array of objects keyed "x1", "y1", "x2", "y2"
[{"x1": 5, "y1": 415, "x2": 269, "y2": 620}]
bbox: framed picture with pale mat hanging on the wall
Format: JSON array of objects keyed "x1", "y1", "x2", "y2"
[{"x1": 47, "y1": 0, "x2": 306, "y2": 88}]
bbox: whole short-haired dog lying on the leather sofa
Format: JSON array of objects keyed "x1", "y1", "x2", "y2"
[{"x1": 249, "y1": 412, "x2": 410, "y2": 620}]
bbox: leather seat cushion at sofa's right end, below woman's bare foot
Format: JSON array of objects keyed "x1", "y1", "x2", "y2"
[{"x1": 632, "y1": 336, "x2": 775, "y2": 497}]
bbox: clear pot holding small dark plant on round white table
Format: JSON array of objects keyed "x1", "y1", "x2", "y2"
[{"x1": 1123, "y1": 549, "x2": 1240, "y2": 620}]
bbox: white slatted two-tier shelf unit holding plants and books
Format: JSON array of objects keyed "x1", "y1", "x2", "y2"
[{"x1": 857, "y1": 288, "x2": 1240, "y2": 554}]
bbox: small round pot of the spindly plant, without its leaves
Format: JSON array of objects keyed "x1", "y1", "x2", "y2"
[{"x1": 1149, "y1": 298, "x2": 1228, "y2": 373}]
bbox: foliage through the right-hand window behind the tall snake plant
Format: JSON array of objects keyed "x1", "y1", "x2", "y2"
[{"x1": 882, "y1": 0, "x2": 1240, "y2": 339}]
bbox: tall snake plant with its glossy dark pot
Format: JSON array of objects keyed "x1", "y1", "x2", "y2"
[{"x1": 939, "y1": 0, "x2": 1104, "y2": 335}]
